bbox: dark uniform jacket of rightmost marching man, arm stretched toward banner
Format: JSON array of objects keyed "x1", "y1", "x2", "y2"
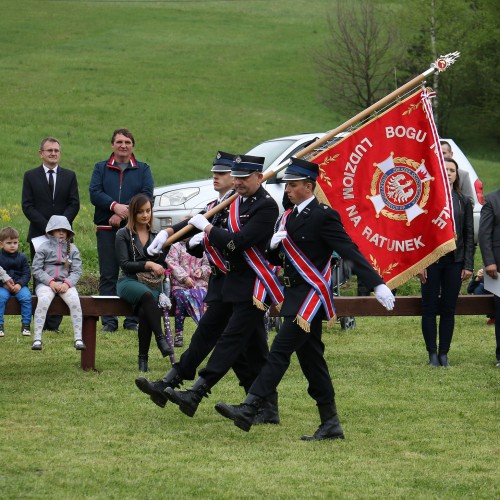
[{"x1": 266, "y1": 198, "x2": 383, "y2": 316}]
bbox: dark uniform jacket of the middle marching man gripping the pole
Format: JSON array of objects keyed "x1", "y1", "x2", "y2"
[{"x1": 209, "y1": 186, "x2": 279, "y2": 302}]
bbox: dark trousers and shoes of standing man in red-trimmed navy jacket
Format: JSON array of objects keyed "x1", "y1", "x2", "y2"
[{"x1": 96, "y1": 229, "x2": 138, "y2": 329}]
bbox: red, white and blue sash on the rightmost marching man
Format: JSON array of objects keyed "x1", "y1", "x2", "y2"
[{"x1": 279, "y1": 209, "x2": 335, "y2": 332}]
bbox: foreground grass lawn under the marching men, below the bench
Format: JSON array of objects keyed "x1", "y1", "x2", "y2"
[{"x1": 0, "y1": 316, "x2": 500, "y2": 498}]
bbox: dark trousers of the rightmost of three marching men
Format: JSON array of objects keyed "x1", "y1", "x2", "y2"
[{"x1": 249, "y1": 315, "x2": 335, "y2": 405}]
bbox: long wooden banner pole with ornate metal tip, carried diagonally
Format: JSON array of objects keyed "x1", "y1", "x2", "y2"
[{"x1": 163, "y1": 52, "x2": 460, "y2": 248}]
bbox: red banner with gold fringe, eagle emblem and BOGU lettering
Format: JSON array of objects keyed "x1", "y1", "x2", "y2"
[{"x1": 312, "y1": 90, "x2": 455, "y2": 288}]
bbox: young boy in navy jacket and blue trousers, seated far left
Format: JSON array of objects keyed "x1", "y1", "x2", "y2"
[{"x1": 0, "y1": 227, "x2": 31, "y2": 337}]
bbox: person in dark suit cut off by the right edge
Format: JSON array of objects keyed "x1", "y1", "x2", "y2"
[{"x1": 478, "y1": 189, "x2": 500, "y2": 367}]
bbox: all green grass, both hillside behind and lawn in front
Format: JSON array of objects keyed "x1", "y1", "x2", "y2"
[{"x1": 0, "y1": 0, "x2": 500, "y2": 499}]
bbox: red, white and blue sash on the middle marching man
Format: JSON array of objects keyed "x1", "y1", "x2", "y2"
[{"x1": 228, "y1": 196, "x2": 283, "y2": 310}]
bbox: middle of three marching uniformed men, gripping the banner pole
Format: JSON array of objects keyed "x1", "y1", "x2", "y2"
[{"x1": 165, "y1": 156, "x2": 279, "y2": 417}]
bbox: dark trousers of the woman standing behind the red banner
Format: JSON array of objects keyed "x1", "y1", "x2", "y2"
[{"x1": 421, "y1": 256, "x2": 463, "y2": 354}]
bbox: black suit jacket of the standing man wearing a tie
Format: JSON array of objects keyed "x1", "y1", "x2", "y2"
[{"x1": 22, "y1": 165, "x2": 80, "y2": 241}]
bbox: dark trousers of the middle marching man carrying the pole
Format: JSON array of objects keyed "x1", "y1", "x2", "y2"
[{"x1": 199, "y1": 301, "x2": 269, "y2": 387}]
